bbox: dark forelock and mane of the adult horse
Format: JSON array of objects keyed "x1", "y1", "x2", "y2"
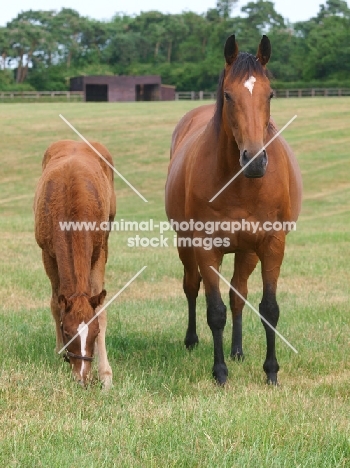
[{"x1": 214, "y1": 52, "x2": 271, "y2": 134}]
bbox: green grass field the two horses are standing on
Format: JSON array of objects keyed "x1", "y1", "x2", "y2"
[{"x1": 0, "y1": 98, "x2": 350, "y2": 468}]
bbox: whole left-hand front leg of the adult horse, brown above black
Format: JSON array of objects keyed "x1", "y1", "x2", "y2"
[{"x1": 196, "y1": 248, "x2": 228, "y2": 385}]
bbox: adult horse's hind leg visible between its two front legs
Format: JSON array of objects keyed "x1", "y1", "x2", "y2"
[{"x1": 230, "y1": 252, "x2": 259, "y2": 360}]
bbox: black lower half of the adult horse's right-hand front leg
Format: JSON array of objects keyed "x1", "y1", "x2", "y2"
[{"x1": 259, "y1": 292, "x2": 279, "y2": 385}]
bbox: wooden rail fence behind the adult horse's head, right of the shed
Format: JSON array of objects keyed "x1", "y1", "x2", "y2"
[{"x1": 175, "y1": 88, "x2": 350, "y2": 101}]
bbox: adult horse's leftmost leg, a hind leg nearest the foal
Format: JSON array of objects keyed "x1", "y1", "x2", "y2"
[{"x1": 178, "y1": 247, "x2": 201, "y2": 349}]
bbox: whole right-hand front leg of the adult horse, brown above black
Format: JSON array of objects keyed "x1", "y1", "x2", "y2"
[{"x1": 258, "y1": 231, "x2": 285, "y2": 385}]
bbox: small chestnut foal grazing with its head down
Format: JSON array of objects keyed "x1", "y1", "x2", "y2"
[{"x1": 34, "y1": 140, "x2": 116, "y2": 388}]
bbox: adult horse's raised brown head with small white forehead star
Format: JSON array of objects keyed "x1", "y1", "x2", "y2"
[{"x1": 218, "y1": 35, "x2": 273, "y2": 178}]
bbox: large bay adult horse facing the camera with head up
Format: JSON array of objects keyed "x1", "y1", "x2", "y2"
[{"x1": 165, "y1": 35, "x2": 302, "y2": 385}]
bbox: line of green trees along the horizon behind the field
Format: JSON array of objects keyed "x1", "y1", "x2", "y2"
[{"x1": 0, "y1": 0, "x2": 350, "y2": 91}]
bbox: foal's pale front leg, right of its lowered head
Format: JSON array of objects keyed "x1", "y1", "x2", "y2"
[{"x1": 91, "y1": 249, "x2": 112, "y2": 389}]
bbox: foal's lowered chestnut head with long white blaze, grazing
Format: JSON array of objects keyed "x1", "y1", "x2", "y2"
[{"x1": 58, "y1": 289, "x2": 106, "y2": 385}]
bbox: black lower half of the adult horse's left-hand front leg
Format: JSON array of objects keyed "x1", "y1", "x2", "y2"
[{"x1": 207, "y1": 293, "x2": 228, "y2": 385}]
